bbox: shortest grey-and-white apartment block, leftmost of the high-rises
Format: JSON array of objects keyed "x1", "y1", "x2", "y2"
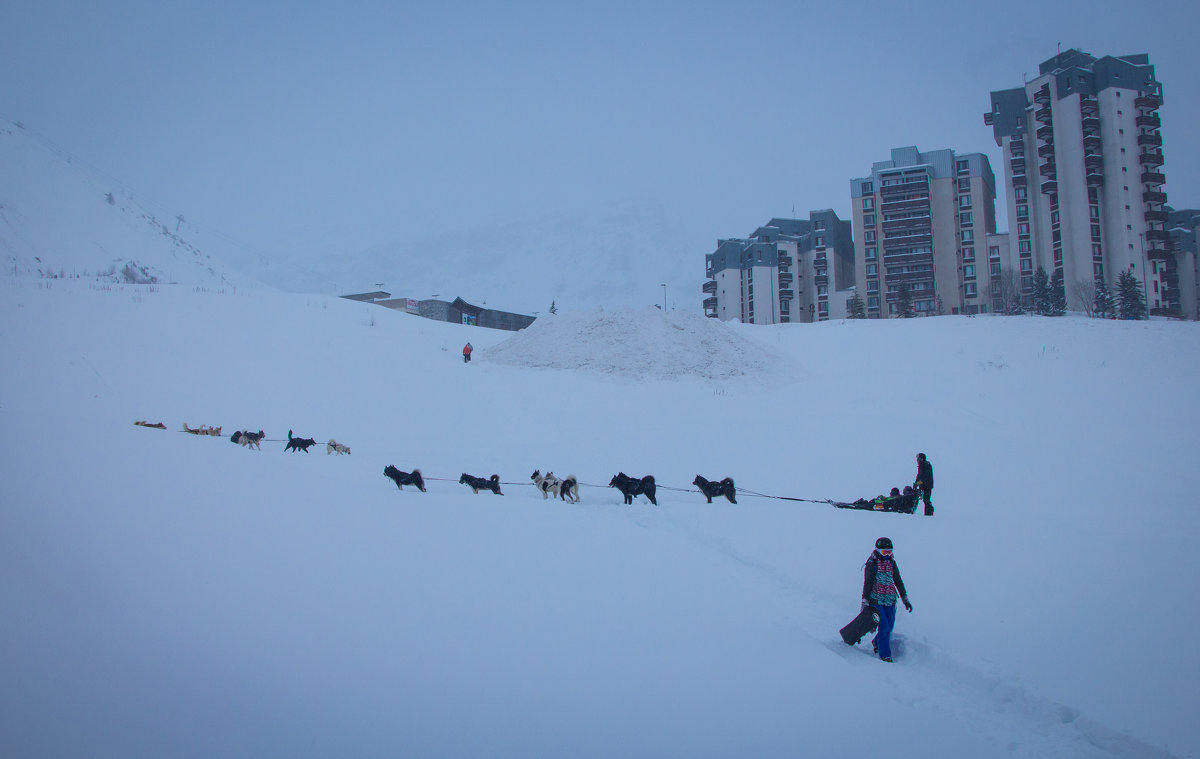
[{"x1": 703, "y1": 210, "x2": 854, "y2": 324}]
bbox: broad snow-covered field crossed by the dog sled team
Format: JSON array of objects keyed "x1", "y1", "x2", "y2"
[{"x1": 0, "y1": 279, "x2": 1200, "y2": 758}]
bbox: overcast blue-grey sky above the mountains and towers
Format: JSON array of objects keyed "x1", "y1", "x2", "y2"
[{"x1": 0, "y1": 0, "x2": 1200, "y2": 265}]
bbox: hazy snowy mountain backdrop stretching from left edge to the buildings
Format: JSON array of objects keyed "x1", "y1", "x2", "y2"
[{"x1": 0, "y1": 120, "x2": 700, "y2": 313}]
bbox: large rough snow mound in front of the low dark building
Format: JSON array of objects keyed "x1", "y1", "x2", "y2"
[{"x1": 479, "y1": 306, "x2": 780, "y2": 380}]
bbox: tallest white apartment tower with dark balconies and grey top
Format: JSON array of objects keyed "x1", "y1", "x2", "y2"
[{"x1": 984, "y1": 49, "x2": 1180, "y2": 315}]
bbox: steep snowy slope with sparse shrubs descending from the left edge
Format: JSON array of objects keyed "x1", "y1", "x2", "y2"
[{"x1": 0, "y1": 119, "x2": 253, "y2": 288}]
